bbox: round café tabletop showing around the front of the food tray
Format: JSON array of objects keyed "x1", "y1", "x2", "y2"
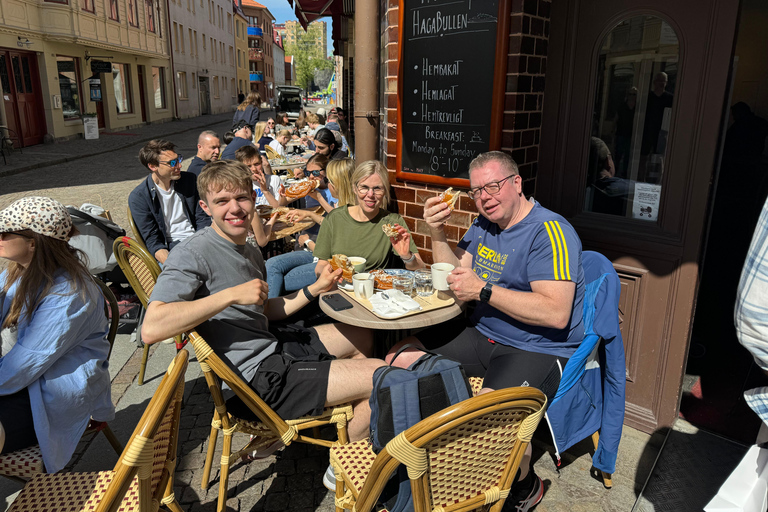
[{"x1": 320, "y1": 290, "x2": 463, "y2": 331}]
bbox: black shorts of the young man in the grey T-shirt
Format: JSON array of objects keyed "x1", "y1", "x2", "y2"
[{"x1": 227, "y1": 324, "x2": 336, "y2": 420}]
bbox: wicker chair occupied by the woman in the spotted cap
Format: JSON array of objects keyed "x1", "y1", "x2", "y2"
[{"x1": 0, "y1": 279, "x2": 123, "y2": 482}]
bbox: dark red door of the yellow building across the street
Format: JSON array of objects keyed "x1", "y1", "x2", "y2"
[{"x1": 3, "y1": 52, "x2": 46, "y2": 146}]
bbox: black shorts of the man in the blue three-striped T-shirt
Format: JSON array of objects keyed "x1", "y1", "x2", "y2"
[{"x1": 416, "y1": 318, "x2": 568, "y2": 400}]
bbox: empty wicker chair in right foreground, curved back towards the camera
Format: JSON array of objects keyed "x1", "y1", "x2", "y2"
[{"x1": 331, "y1": 388, "x2": 547, "y2": 512}]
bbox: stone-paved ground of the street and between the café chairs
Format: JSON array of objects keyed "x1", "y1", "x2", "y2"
[{"x1": 0, "y1": 107, "x2": 657, "y2": 512}]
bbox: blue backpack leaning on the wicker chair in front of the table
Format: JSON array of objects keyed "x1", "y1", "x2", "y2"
[{"x1": 370, "y1": 345, "x2": 472, "y2": 512}]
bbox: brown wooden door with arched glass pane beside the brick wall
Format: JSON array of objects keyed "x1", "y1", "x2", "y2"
[{"x1": 536, "y1": 0, "x2": 739, "y2": 432}]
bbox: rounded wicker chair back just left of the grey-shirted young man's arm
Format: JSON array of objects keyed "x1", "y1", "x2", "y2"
[{"x1": 112, "y1": 236, "x2": 186, "y2": 386}]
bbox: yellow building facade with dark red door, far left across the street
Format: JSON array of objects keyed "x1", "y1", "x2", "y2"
[{"x1": 0, "y1": 0, "x2": 174, "y2": 146}]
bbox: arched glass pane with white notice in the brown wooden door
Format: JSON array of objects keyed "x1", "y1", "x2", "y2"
[{"x1": 584, "y1": 15, "x2": 679, "y2": 221}]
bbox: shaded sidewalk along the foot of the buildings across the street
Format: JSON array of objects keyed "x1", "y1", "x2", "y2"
[{"x1": 0, "y1": 110, "x2": 274, "y2": 177}]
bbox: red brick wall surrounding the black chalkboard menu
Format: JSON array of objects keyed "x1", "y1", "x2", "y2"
[{"x1": 381, "y1": 0, "x2": 552, "y2": 264}]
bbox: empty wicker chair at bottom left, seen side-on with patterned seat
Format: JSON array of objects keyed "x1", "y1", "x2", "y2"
[{"x1": 10, "y1": 350, "x2": 189, "y2": 512}]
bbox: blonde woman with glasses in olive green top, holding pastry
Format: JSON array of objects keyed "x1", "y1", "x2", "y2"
[{"x1": 314, "y1": 160, "x2": 424, "y2": 275}]
